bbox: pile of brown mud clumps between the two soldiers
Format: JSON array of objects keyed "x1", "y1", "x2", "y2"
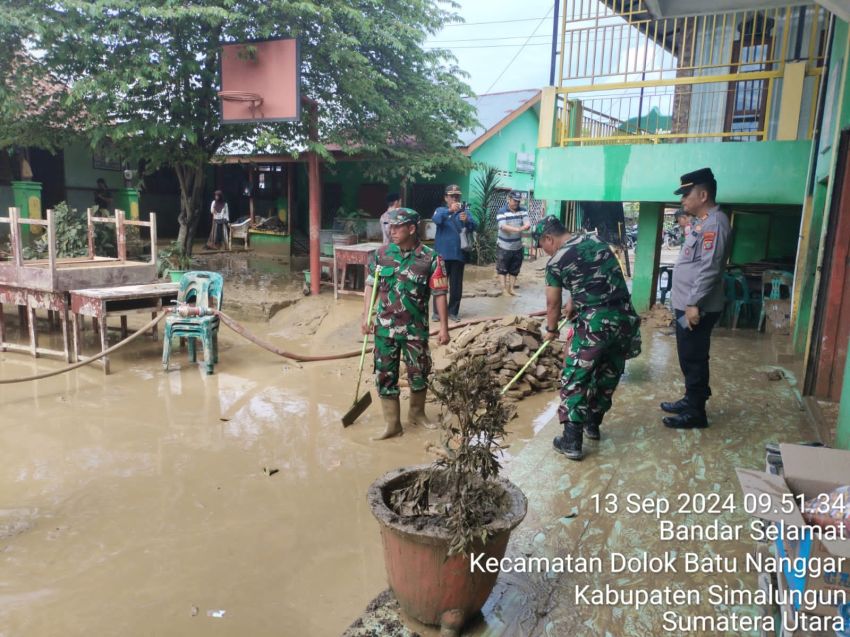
[{"x1": 436, "y1": 316, "x2": 564, "y2": 401}]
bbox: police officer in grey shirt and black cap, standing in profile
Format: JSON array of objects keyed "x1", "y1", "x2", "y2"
[{"x1": 661, "y1": 168, "x2": 730, "y2": 429}]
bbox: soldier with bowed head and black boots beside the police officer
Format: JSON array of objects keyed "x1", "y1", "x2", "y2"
[{"x1": 534, "y1": 217, "x2": 640, "y2": 460}]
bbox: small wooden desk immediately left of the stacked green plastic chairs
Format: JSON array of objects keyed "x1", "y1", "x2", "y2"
[{"x1": 69, "y1": 283, "x2": 179, "y2": 374}]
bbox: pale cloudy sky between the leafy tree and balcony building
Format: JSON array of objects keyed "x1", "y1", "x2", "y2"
[{"x1": 426, "y1": 0, "x2": 554, "y2": 95}]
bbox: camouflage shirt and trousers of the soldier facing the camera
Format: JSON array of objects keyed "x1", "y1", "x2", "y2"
[{"x1": 366, "y1": 243, "x2": 448, "y2": 397}]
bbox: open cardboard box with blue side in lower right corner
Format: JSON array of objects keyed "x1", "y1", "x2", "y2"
[{"x1": 736, "y1": 444, "x2": 850, "y2": 616}]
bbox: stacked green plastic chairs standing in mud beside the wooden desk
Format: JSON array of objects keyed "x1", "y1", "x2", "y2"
[{"x1": 162, "y1": 271, "x2": 224, "y2": 374}]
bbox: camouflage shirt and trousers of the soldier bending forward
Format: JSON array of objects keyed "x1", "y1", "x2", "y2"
[{"x1": 546, "y1": 234, "x2": 640, "y2": 423}]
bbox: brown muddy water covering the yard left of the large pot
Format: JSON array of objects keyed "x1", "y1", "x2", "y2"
[{"x1": 0, "y1": 262, "x2": 553, "y2": 637}]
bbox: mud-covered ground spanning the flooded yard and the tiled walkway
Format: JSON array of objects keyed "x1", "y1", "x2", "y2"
[{"x1": 0, "y1": 260, "x2": 812, "y2": 637}]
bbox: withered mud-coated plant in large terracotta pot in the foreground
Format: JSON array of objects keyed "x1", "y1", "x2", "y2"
[{"x1": 368, "y1": 357, "x2": 528, "y2": 636}]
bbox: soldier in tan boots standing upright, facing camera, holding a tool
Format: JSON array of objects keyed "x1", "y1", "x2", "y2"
[{"x1": 361, "y1": 208, "x2": 449, "y2": 440}]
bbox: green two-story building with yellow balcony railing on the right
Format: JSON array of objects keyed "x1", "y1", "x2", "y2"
[{"x1": 535, "y1": 0, "x2": 850, "y2": 448}]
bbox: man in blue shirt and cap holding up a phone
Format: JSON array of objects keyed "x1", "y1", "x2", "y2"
[{"x1": 431, "y1": 184, "x2": 476, "y2": 321}]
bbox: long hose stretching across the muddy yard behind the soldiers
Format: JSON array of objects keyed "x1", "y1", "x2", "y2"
[{"x1": 0, "y1": 307, "x2": 545, "y2": 385}]
